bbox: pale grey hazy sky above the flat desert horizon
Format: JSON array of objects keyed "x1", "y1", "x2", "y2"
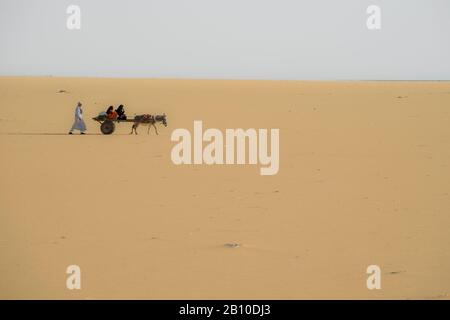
[{"x1": 0, "y1": 0, "x2": 450, "y2": 80}]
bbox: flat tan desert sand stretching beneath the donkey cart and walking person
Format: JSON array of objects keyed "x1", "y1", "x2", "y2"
[{"x1": 0, "y1": 78, "x2": 450, "y2": 299}]
